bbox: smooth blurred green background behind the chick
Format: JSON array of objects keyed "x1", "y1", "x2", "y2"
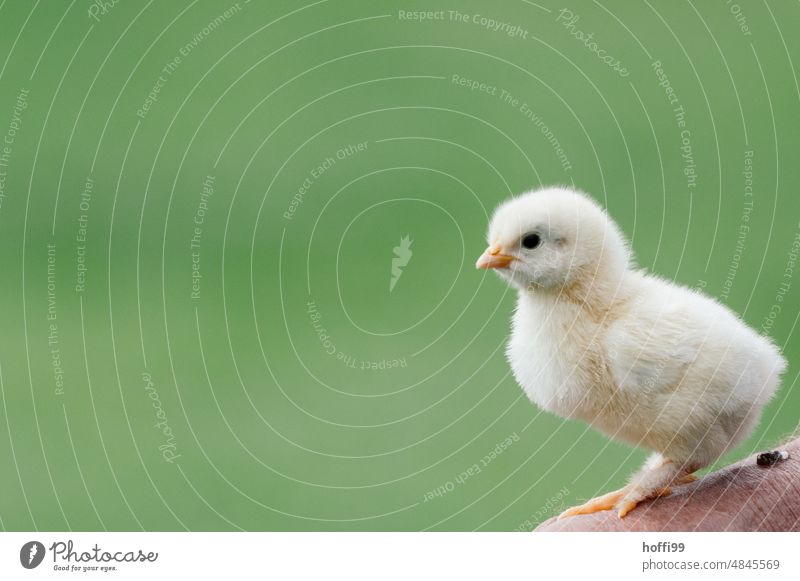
[{"x1": 0, "y1": 0, "x2": 800, "y2": 530}]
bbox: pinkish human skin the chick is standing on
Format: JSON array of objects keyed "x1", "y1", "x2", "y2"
[{"x1": 536, "y1": 438, "x2": 800, "y2": 532}]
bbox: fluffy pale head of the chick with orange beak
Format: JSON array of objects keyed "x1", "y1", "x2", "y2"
[{"x1": 476, "y1": 188, "x2": 630, "y2": 291}]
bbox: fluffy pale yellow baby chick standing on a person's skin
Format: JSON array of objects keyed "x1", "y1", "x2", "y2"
[{"x1": 476, "y1": 188, "x2": 786, "y2": 517}]
